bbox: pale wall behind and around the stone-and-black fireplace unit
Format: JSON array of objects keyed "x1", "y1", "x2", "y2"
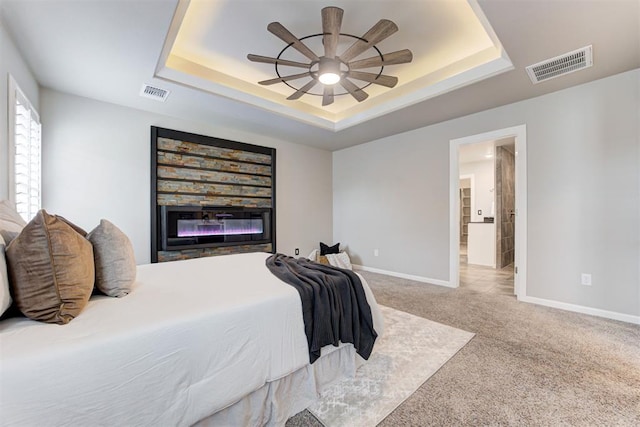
[{"x1": 40, "y1": 89, "x2": 332, "y2": 264}]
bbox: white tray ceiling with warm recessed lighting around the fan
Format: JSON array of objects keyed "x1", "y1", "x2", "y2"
[{"x1": 0, "y1": 0, "x2": 640, "y2": 150}]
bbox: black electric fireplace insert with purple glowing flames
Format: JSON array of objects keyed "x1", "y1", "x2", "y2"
[{"x1": 160, "y1": 206, "x2": 272, "y2": 251}]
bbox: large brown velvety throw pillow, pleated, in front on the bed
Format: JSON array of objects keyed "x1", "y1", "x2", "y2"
[{"x1": 6, "y1": 209, "x2": 95, "y2": 324}]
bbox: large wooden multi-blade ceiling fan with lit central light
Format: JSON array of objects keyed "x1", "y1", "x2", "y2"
[{"x1": 247, "y1": 6, "x2": 413, "y2": 106}]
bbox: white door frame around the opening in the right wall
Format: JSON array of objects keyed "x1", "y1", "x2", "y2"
[{"x1": 449, "y1": 124, "x2": 527, "y2": 300}]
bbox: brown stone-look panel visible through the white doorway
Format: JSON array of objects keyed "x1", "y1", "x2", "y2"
[{"x1": 495, "y1": 146, "x2": 516, "y2": 268}]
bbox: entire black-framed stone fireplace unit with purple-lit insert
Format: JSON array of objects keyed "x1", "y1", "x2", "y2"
[{"x1": 151, "y1": 126, "x2": 276, "y2": 262}]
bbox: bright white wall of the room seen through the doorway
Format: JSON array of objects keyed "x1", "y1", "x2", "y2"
[{"x1": 460, "y1": 159, "x2": 496, "y2": 221}]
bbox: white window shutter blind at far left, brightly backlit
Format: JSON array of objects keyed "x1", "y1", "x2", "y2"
[{"x1": 9, "y1": 76, "x2": 42, "y2": 221}]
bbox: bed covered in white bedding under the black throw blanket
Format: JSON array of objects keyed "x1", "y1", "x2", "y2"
[{"x1": 0, "y1": 253, "x2": 383, "y2": 426}]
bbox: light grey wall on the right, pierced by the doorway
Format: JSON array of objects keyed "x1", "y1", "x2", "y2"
[{"x1": 333, "y1": 69, "x2": 640, "y2": 316}]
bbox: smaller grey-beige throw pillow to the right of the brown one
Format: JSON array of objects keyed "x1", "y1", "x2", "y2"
[{"x1": 87, "y1": 219, "x2": 136, "y2": 297}]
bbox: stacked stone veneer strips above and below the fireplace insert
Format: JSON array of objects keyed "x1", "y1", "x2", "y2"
[{"x1": 156, "y1": 137, "x2": 274, "y2": 262}]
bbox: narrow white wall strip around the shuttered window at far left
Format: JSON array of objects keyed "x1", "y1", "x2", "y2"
[{"x1": 0, "y1": 16, "x2": 40, "y2": 200}]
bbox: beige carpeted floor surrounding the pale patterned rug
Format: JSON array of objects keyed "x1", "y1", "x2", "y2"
[{"x1": 287, "y1": 272, "x2": 640, "y2": 427}]
